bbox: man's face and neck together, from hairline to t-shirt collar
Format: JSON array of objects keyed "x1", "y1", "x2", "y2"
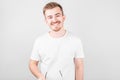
[{"x1": 45, "y1": 7, "x2": 65, "y2": 38}]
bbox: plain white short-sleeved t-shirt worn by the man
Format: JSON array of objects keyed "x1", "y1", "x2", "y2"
[{"x1": 31, "y1": 31, "x2": 84, "y2": 80}]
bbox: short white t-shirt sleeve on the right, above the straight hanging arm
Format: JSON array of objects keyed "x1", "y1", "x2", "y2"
[{"x1": 75, "y1": 40, "x2": 84, "y2": 58}]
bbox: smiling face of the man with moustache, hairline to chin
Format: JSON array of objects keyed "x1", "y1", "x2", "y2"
[{"x1": 45, "y1": 7, "x2": 65, "y2": 32}]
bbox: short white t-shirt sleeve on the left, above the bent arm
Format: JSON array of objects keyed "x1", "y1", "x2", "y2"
[{"x1": 30, "y1": 40, "x2": 40, "y2": 61}]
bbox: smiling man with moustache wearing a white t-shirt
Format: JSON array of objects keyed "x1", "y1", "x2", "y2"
[{"x1": 29, "y1": 2, "x2": 84, "y2": 80}]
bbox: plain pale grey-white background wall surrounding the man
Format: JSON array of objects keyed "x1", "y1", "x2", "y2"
[{"x1": 0, "y1": 0, "x2": 120, "y2": 80}]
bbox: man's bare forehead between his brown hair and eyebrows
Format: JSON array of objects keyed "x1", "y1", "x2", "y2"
[{"x1": 45, "y1": 7, "x2": 62, "y2": 16}]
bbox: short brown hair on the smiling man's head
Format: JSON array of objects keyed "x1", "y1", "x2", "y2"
[{"x1": 43, "y1": 2, "x2": 64, "y2": 15}]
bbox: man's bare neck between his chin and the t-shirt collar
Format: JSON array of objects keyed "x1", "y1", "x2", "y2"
[{"x1": 49, "y1": 28, "x2": 66, "y2": 38}]
